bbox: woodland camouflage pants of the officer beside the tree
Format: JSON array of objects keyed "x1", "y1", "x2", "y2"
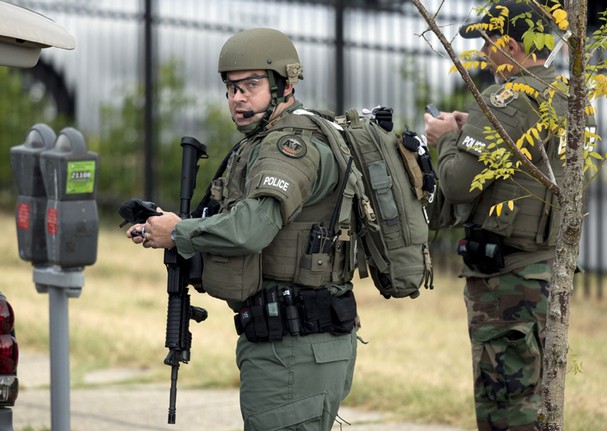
[{"x1": 465, "y1": 264, "x2": 548, "y2": 431}]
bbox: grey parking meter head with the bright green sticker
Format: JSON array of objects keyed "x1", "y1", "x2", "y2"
[{"x1": 40, "y1": 127, "x2": 99, "y2": 268}]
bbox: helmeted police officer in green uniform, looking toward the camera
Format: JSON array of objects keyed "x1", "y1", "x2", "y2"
[{"x1": 127, "y1": 28, "x2": 356, "y2": 431}]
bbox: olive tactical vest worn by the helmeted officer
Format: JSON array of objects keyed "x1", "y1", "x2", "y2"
[{"x1": 203, "y1": 115, "x2": 353, "y2": 301}]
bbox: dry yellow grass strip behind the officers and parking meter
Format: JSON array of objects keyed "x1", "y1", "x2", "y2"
[{"x1": 0, "y1": 214, "x2": 607, "y2": 431}]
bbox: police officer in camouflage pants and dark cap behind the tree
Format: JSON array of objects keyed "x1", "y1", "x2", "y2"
[{"x1": 424, "y1": 0, "x2": 593, "y2": 431}]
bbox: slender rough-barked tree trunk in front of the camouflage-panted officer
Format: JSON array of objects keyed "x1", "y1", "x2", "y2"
[{"x1": 540, "y1": 0, "x2": 588, "y2": 431}]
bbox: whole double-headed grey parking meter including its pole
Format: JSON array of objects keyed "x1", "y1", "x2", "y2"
[{"x1": 11, "y1": 125, "x2": 99, "y2": 431}]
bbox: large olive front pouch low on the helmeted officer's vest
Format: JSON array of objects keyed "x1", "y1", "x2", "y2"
[{"x1": 202, "y1": 253, "x2": 262, "y2": 301}]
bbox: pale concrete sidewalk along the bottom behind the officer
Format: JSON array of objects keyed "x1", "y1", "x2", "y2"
[{"x1": 13, "y1": 354, "x2": 472, "y2": 431}]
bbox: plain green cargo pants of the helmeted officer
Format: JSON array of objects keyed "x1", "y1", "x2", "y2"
[{"x1": 236, "y1": 331, "x2": 356, "y2": 431}]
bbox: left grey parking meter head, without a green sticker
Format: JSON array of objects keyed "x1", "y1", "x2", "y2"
[{"x1": 10, "y1": 124, "x2": 57, "y2": 265}]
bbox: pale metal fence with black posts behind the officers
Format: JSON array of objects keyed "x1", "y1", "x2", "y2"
[{"x1": 0, "y1": 0, "x2": 607, "y2": 296}]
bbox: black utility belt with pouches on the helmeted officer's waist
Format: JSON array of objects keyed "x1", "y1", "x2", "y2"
[{"x1": 234, "y1": 287, "x2": 356, "y2": 343}]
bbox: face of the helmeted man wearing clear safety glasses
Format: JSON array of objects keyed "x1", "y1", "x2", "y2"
[{"x1": 226, "y1": 70, "x2": 271, "y2": 126}]
